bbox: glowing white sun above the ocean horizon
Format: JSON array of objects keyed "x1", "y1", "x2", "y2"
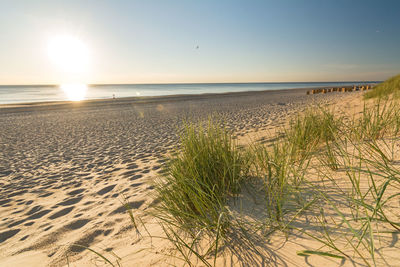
[{"x1": 48, "y1": 35, "x2": 89, "y2": 73}]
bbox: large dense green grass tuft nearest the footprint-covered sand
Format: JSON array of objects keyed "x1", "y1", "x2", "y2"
[{"x1": 156, "y1": 121, "x2": 248, "y2": 232}]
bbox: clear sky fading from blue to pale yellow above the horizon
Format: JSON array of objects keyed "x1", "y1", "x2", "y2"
[{"x1": 0, "y1": 0, "x2": 400, "y2": 84}]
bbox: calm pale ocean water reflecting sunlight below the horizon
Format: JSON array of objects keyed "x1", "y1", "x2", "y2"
[{"x1": 0, "y1": 81, "x2": 378, "y2": 104}]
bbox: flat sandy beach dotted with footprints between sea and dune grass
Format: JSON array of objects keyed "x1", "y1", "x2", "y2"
[{"x1": 0, "y1": 89, "x2": 396, "y2": 266}]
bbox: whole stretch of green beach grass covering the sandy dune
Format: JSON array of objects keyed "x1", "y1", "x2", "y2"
[{"x1": 112, "y1": 76, "x2": 400, "y2": 266}]
